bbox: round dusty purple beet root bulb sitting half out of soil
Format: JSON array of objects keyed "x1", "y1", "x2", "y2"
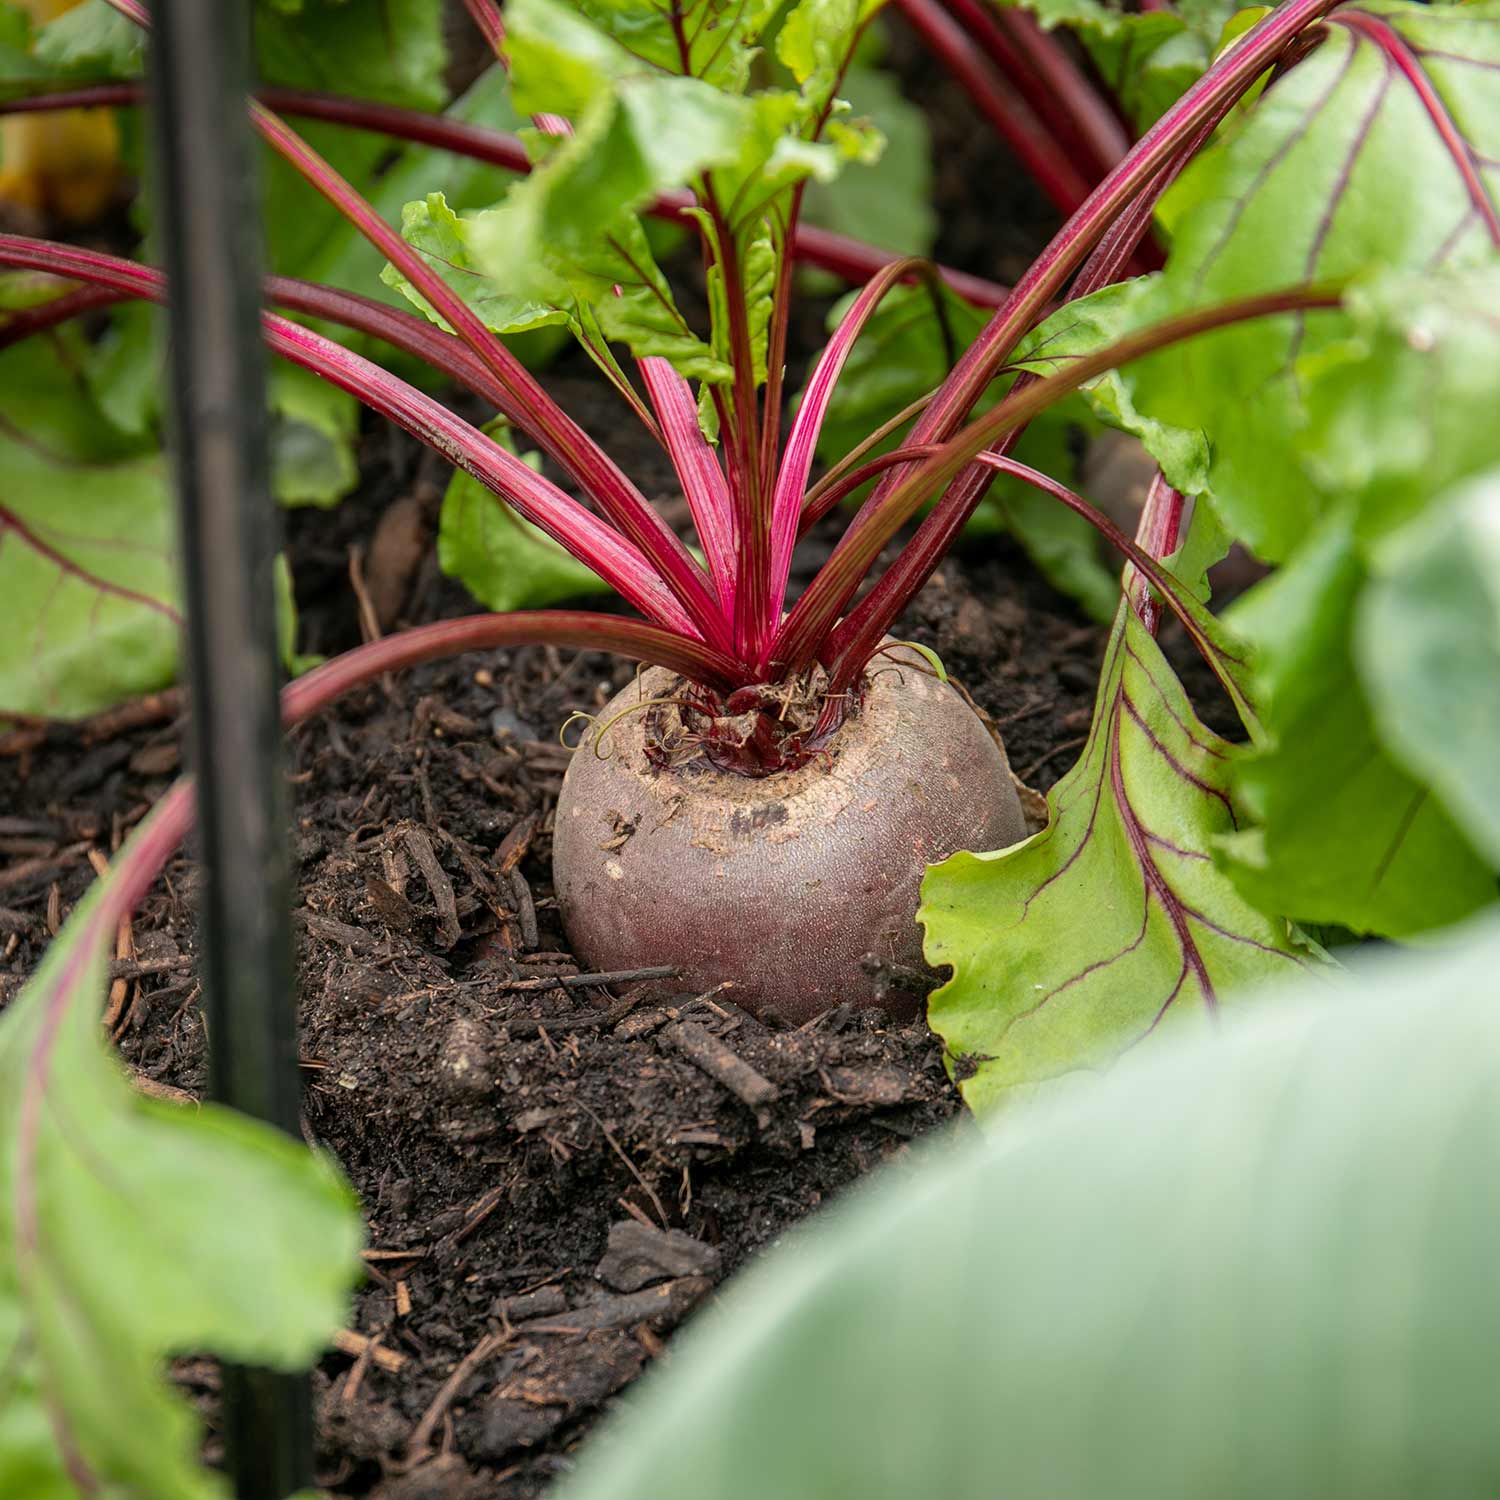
[{"x1": 554, "y1": 663, "x2": 1028, "y2": 1025}]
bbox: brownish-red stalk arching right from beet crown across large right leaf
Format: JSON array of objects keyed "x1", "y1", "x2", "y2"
[{"x1": 773, "y1": 287, "x2": 1340, "y2": 689}]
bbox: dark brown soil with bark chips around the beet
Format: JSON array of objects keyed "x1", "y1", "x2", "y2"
[{"x1": 0, "y1": 17, "x2": 1230, "y2": 1500}]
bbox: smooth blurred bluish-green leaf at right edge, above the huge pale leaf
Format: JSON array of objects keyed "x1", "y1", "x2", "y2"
[{"x1": 1355, "y1": 470, "x2": 1500, "y2": 870}]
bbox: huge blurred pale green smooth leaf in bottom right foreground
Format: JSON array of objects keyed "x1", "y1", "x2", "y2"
[{"x1": 555, "y1": 923, "x2": 1500, "y2": 1500}]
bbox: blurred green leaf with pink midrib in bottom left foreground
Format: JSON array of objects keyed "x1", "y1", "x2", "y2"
[{"x1": 0, "y1": 810, "x2": 362, "y2": 1500}]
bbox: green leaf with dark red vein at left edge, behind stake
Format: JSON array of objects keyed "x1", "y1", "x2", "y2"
[{"x1": 0, "y1": 338, "x2": 182, "y2": 719}]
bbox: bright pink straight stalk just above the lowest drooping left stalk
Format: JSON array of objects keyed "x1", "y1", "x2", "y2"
[{"x1": 0, "y1": 236, "x2": 696, "y2": 638}]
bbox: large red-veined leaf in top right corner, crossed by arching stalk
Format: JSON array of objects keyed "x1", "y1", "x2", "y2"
[{"x1": 1127, "y1": 0, "x2": 1500, "y2": 561}]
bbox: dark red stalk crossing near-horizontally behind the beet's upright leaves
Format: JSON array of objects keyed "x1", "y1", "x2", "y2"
[{"x1": 0, "y1": 84, "x2": 1008, "y2": 308}]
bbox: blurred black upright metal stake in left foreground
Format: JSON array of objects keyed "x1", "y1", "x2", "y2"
[{"x1": 152, "y1": 0, "x2": 312, "y2": 1500}]
